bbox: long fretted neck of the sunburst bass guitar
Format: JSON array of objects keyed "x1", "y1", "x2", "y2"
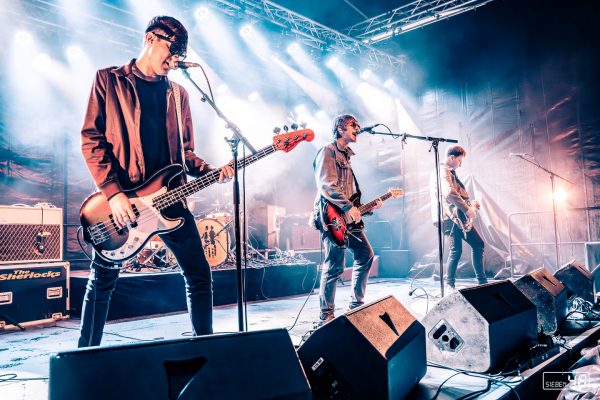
[{"x1": 153, "y1": 145, "x2": 277, "y2": 210}]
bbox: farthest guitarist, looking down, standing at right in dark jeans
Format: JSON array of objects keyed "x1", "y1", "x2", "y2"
[{"x1": 429, "y1": 146, "x2": 487, "y2": 292}]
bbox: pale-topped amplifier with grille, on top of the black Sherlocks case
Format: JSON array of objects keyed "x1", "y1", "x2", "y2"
[{"x1": 0, "y1": 206, "x2": 63, "y2": 264}]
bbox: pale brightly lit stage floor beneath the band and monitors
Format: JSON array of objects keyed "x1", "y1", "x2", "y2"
[{"x1": 0, "y1": 279, "x2": 598, "y2": 400}]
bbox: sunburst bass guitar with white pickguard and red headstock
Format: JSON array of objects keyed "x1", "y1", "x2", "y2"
[{"x1": 79, "y1": 129, "x2": 315, "y2": 263}]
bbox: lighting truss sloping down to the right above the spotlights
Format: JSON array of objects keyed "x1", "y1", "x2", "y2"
[{"x1": 213, "y1": 0, "x2": 404, "y2": 67}]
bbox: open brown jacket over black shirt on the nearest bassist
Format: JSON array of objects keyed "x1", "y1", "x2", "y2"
[{"x1": 81, "y1": 59, "x2": 213, "y2": 199}]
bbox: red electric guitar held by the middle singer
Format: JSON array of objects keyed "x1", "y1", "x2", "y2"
[{"x1": 321, "y1": 188, "x2": 404, "y2": 247}]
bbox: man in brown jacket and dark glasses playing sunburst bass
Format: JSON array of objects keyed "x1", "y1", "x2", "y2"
[{"x1": 79, "y1": 16, "x2": 233, "y2": 347}]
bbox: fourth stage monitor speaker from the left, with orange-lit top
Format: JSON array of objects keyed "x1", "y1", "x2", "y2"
[{"x1": 515, "y1": 267, "x2": 567, "y2": 335}]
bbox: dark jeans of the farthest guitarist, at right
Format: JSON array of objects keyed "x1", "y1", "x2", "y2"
[{"x1": 443, "y1": 220, "x2": 487, "y2": 286}]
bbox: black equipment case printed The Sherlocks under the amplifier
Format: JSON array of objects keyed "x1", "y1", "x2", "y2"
[{"x1": 0, "y1": 262, "x2": 70, "y2": 329}]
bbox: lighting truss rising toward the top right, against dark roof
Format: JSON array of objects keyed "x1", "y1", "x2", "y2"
[{"x1": 344, "y1": 0, "x2": 493, "y2": 44}]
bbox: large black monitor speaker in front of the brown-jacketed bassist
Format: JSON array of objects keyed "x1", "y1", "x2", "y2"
[{"x1": 49, "y1": 329, "x2": 311, "y2": 400}]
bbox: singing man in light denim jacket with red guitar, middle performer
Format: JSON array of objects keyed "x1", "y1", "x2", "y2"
[{"x1": 313, "y1": 114, "x2": 381, "y2": 324}]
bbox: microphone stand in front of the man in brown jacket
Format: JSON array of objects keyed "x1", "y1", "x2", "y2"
[{"x1": 181, "y1": 68, "x2": 256, "y2": 332}]
